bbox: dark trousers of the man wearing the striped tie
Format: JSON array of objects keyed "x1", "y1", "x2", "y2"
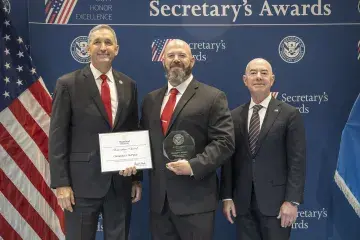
[{"x1": 236, "y1": 186, "x2": 291, "y2": 240}]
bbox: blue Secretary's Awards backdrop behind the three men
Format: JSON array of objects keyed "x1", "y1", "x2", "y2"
[{"x1": 7, "y1": 0, "x2": 360, "y2": 240}]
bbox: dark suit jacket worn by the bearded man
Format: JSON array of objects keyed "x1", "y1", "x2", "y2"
[{"x1": 141, "y1": 79, "x2": 234, "y2": 215}]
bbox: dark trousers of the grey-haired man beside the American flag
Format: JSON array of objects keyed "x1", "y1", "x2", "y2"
[{"x1": 65, "y1": 183, "x2": 131, "y2": 240}]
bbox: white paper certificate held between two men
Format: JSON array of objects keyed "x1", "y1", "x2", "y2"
[{"x1": 99, "y1": 130, "x2": 152, "y2": 172}]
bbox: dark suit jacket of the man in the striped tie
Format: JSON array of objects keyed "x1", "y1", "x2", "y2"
[{"x1": 221, "y1": 98, "x2": 305, "y2": 216}]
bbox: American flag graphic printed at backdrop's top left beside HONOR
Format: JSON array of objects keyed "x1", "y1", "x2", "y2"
[{"x1": 45, "y1": 0, "x2": 78, "y2": 24}]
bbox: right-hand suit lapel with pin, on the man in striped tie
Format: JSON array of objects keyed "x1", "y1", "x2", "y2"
[{"x1": 255, "y1": 98, "x2": 281, "y2": 155}]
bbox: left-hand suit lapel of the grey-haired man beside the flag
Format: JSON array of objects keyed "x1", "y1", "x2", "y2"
[{"x1": 83, "y1": 65, "x2": 109, "y2": 126}]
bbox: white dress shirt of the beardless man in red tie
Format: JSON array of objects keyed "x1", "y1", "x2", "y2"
[{"x1": 90, "y1": 63, "x2": 118, "y2": 124}]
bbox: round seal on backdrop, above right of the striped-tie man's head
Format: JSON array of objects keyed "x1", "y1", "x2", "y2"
[{"x1": 279, "y1": 36, "x2": 305, "y2": 63}]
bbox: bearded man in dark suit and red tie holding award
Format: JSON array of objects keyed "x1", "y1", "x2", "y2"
[{"x1": 140, "y1": 40, "x2": 234, "y2": 240}]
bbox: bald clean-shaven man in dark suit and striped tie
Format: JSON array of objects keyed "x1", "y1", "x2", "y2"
[{"x1": 221, "y1": 58, "x2": 305, "y2": 240}]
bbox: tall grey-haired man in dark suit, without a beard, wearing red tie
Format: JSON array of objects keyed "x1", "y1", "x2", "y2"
[{"x1": 49, "y1": 25, "x2": 141, "y2": 240}]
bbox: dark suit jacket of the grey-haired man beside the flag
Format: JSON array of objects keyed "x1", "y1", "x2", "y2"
[{"x1": 49, "y1": 65, "x2": 138, "y2": 198}]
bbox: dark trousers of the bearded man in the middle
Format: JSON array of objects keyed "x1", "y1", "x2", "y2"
[{"x1": 150, "y1": 198, "x2": 215, "y2": 240}]
